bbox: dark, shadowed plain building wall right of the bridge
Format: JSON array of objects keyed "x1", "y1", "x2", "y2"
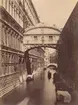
[{"x1": 57, "y1": 3, "x2": 78, "y2": 91}]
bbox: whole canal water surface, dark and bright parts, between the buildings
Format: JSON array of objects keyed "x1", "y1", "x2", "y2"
[{"x1": 0, "y1": 68, "x2": 56, "y2": 105}]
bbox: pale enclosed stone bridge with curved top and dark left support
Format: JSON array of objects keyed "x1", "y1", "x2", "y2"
[{"x1": 23, "y1": 24, "x2": 61, "y2": 73}]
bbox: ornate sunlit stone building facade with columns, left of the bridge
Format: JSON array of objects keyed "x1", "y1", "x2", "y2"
[{"x1": 0, "y1": 0, "x2": 39, "y2": 97}]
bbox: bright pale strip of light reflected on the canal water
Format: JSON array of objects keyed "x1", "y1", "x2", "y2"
[{"x1": 42, "y1": 69, "x2": 56, "y2": 105}]
